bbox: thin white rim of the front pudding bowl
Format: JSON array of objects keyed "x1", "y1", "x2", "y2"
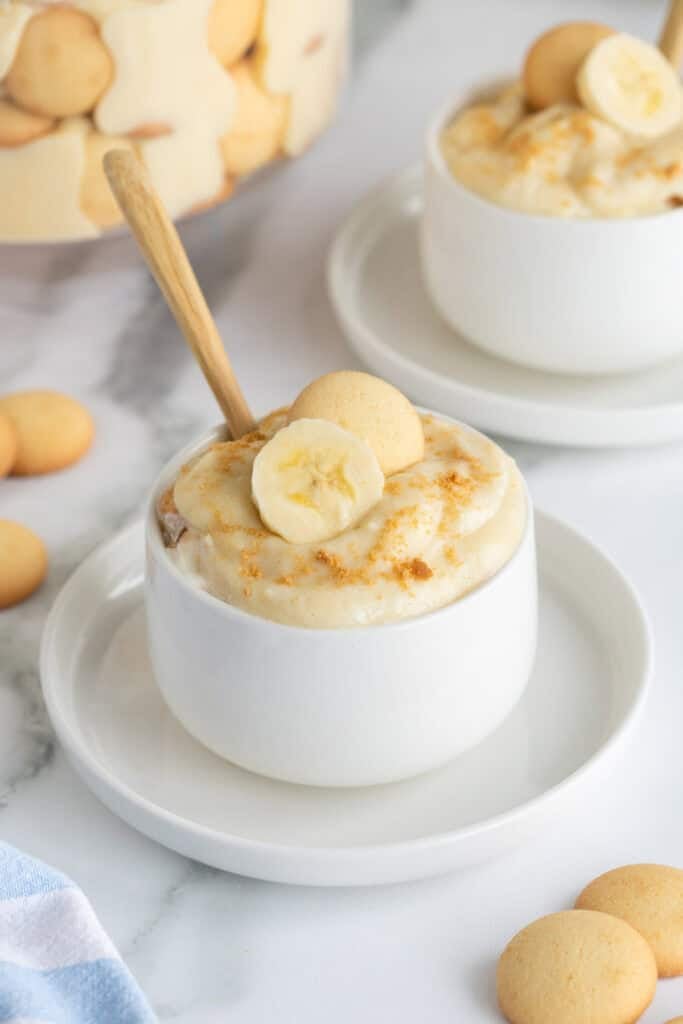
[{"x1": 144, "y1": 406, "x2": 533, "y2": 636}]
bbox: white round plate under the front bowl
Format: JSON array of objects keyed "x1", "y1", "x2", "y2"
[{"x1": 41, "y1": 513, "x2": 651, "y2": 886}]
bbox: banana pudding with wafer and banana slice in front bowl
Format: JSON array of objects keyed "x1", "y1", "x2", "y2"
[{"x1": 158, "y1": 373, "x2": 527, "y2": 628}]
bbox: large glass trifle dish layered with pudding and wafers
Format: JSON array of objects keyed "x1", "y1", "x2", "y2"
[{"x1": 0, "y1": 0, "x2": 350, "y2": 241}]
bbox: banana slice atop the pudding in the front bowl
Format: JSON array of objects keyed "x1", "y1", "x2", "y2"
[{"x1": 252, "y1": 420, "x2": 384, "y2": 544}]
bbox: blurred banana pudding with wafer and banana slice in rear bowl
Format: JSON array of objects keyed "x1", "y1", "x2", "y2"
[{"x1": 440, "y1": 23, "x2": 683, "y2": 218}]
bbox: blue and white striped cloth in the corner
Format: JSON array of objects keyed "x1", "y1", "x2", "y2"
[{"x1": 0, "y1": 843, "x2": 156, "y2": 1024}]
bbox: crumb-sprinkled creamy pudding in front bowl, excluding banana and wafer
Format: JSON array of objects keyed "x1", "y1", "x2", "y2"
[{"x1": 159, "y1": 411, "x2": 526, "y2": 628}]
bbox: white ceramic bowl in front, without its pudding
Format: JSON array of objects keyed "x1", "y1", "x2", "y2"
[{"x1": 145, "y1": 415, "x2": 537, "y2": 786}]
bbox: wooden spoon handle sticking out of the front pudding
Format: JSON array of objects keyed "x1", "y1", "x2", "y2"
[{"x1": 103, "y1": 150, "x2": 255, "y2": 437}]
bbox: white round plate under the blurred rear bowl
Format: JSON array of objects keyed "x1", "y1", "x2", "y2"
[{"x1": 329, "y1": 167, "x2": 683, "y2": 446}]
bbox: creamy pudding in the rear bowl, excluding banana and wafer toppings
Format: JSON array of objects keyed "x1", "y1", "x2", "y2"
[{"x1": 440, "y1": 83, "x2": 683, "y2": 218}]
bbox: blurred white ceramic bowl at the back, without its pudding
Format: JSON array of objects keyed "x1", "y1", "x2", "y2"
[{"x1": 421, "y1": 84, "x2": 683, "y2": 374}]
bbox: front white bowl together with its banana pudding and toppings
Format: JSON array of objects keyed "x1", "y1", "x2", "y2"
[{"x1": 146, "y1": 372, "x2": 537, "y2": 785}]
